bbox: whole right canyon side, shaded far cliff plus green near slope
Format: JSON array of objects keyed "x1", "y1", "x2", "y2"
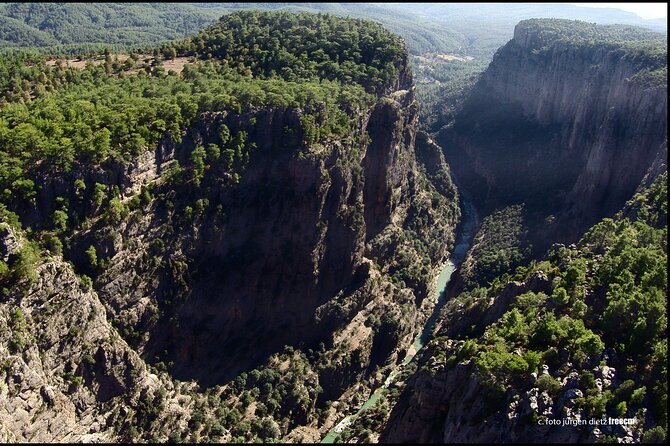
[{"x1": 380, "y1": 20, "x2": 667, "y2": 443}]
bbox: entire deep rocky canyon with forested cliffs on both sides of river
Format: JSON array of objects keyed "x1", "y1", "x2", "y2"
[{"x1": 0, "y1": 11, "x2": 667, "y2": 443}]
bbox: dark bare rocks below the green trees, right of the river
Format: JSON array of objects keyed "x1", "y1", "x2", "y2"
[{"x1": 380, "y1": 271, "x2": 644, "y2": 443}]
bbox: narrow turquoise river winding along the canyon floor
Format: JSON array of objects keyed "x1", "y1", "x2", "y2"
[{"x1": 321, "y1": 191, "x2": 479, "y2": 443}]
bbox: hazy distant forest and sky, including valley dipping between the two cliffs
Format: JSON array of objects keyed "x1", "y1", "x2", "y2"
[{"x1": 0, "y1": 2, "x2": 664, "y2": 132}]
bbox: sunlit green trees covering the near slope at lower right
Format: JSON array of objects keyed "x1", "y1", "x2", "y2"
[{"x1": 426, "y1": 172, "x2": 668, "y2": 441}]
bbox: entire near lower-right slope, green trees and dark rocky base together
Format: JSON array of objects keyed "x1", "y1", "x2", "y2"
[{"x1": 381, "y1": 170, "x2": 667, "y2": 443}]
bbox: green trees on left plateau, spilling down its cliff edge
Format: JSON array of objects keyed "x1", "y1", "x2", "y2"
[{"x1": 0, "y1": 12, "x2": 406, "y2": 386}]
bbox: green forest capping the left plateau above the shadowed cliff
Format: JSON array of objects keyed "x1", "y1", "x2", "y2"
[{"x1": 0, "y1": 12, "x2": 406, "y2": 254}]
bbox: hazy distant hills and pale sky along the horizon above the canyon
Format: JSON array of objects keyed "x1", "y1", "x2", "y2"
[{"x1": 0, "y1": 3, "x2": 667, "y2": 58}]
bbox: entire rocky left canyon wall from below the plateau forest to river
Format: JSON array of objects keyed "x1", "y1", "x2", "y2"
[{"x1": 0, "y1": 14, "x2": 460, "y2": 441}]
